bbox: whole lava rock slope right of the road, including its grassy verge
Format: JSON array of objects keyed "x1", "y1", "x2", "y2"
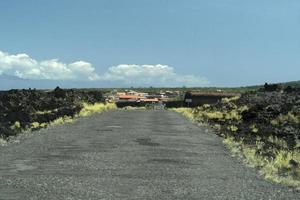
[{"x1": 184, "y1": 84, "x2": 300, "y2": 187}]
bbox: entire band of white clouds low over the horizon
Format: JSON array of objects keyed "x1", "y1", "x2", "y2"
[{"x1": 0, "y1": 51, "x2": 208, "y2": 86}]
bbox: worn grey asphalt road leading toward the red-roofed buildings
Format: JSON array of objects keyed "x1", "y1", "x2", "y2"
[{"x1": 0, "y1": 110, "x2": 300, "y2": 200}]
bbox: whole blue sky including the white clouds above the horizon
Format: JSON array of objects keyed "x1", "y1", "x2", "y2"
[{"x1": 0, "y1": 0, "x2": 300, "y2": 86}]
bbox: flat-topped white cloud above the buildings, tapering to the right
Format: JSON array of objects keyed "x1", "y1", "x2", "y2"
[{"x1": 101, "y1": 64, "x2": 208, "y2": 86}]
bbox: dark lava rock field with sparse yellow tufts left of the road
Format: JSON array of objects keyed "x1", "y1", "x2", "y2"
[{"x1": 0, "y1": 87, "x2": 104, "y2": 138}]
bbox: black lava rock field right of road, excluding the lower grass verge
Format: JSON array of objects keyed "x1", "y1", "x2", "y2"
[{"x1": 193, "y1": 83, "x2": 300, "y2": 149}]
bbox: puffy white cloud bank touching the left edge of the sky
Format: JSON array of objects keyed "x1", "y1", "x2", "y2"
[{"x1": 0, "y1": 51, "x2": 100, "y2": 80}]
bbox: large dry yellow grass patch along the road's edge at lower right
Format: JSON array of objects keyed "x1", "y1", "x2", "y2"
[{"x1": 223, "y1": 137, "x2": 300, "y2": 187}]
